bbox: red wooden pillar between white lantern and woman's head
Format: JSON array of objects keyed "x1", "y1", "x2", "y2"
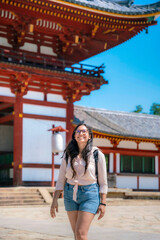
[{"x1": 66, "y1": 98, "x2": 74, "y2": 144}]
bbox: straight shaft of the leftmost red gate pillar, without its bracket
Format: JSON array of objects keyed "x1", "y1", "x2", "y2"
[{"x1": 13, "y1": 94, "x2": 23, "y2": 186}]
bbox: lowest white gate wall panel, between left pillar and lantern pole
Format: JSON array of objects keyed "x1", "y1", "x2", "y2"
[{"x1": 22, "y1": 168, "x2": 52, "y2": 181}]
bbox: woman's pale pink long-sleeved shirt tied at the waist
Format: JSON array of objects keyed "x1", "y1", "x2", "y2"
[{"x1": 56, "y1": 147, "x2": 108, "y2": 199}]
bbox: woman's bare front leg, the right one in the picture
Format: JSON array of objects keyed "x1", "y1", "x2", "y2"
[{"x1": 75, "y1": 211, "x2": 95, "y2": 240}]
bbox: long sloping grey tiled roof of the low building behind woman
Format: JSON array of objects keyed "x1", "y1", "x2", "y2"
[{"x1": 74, "y1": 106, "x2": 160, "y2": 139}]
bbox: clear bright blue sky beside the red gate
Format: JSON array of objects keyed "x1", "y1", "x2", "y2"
[{"x1": 75, "y1": 0, "x2": 160, "y2": 113}]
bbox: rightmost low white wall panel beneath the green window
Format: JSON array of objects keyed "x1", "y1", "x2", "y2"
[{"x1": 139, "y1": 177, "x2": 159, "y2": 190}]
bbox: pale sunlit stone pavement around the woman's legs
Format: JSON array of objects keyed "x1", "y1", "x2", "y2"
[{"x1": 0, "y1": 199, "x2": 160, "y2": 240}]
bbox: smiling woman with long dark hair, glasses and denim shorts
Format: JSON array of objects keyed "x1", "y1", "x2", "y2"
[{"x1": 50, "y1": 124, "x2": 108, "y2": 240}]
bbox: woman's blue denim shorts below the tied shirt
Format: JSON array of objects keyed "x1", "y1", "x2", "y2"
[{"x1": 64, "y1": 183, "x2": 100, "y2": 214}]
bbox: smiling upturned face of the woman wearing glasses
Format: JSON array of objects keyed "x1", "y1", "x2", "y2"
[{"x1": 75, "y1": 125, "x2": 90, "y2": 145}]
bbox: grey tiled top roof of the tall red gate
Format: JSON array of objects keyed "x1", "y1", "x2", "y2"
[{"x1": 63, "y1": 0, "x2": 160, "y2": 15}]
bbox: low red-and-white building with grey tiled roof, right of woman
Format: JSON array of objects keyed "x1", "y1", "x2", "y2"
[{"x1": 73, "y1": 106, "x2": 160, "y2": 191}]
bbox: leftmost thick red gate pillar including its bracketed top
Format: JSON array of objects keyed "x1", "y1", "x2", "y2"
[{"x1": 10, "y1": 72, "x2": 31, "y2": 186}]
